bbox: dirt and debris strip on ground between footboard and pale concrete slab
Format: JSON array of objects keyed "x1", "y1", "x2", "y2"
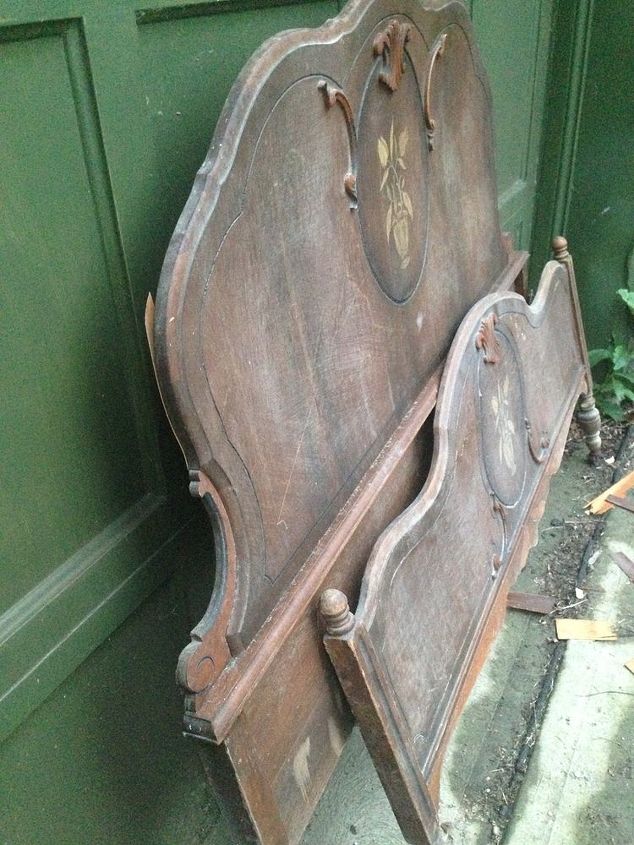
[{"x1": 440, "y1": 420, "x2": 634, "y2": 845}]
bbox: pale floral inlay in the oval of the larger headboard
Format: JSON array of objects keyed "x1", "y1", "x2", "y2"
[{"x1": 377, "y1": 121, "x2": 414, "y2": 270}]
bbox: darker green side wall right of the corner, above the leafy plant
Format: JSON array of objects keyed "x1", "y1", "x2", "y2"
[{"x1": 533, "y1": 0, "x2": 634, "y2": 348}]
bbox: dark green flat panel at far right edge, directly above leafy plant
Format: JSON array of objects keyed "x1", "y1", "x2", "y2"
[{"x1": 563, "y1": 0, "x2": 634, "y2": 347}]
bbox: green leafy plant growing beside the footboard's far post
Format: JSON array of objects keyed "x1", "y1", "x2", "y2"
[{"x1": 588, "y1": 288, "x2": 634, "y2": 422}]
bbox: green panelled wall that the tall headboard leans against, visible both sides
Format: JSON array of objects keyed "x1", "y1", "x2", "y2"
[{"x1": 0, "y1": 0, "x2": 584, "y2": 845}]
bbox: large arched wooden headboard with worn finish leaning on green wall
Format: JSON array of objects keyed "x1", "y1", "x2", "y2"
[{"x1": 147, "y1": 0, "x2": 540, "y2": 843}]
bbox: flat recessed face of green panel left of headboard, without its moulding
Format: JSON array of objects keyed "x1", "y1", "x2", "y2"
[{"x1": 0, "y1": 23, "x2": 143, "y2": 613}]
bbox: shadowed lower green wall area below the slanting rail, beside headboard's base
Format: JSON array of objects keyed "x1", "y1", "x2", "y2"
[{"x1": 0, "y1": 536, "x2": 226, "y2": 845}]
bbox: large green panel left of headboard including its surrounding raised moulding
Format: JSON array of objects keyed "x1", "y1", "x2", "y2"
[{"x1": 0, "y1": 11, "x2": 200, "y2": 736}]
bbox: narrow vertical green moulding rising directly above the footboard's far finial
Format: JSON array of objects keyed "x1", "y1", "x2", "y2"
[{"x1": 552, "y1": 0, "x2": 594, "y2": 233}]
